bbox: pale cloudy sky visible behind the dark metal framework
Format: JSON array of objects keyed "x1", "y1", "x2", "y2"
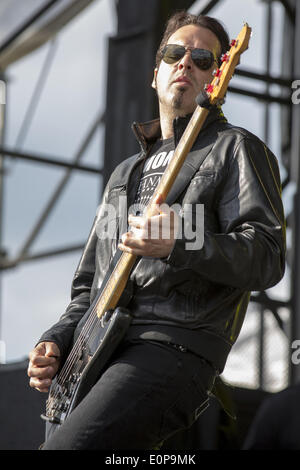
[{"x1": 0, "y1": 0, "x2": 293, "y2": 388}]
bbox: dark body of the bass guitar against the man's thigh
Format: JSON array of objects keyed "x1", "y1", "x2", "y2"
[{"x1": 42, "y1": 307, "x2": 132, "y2": 437}]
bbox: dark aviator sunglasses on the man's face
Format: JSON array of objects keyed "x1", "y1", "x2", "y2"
[{"x1": 162, "y1": 44, "x2": 216, "y2": 70}]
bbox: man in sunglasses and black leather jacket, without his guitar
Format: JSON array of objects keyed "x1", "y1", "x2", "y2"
[{"x1": 28, "y1": 12, "x2": 285, "y2": 450}]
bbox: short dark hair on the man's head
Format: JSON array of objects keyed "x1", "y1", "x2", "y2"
[{"x1": 156, "y1": 11, "x2": 230, "y2": 67}]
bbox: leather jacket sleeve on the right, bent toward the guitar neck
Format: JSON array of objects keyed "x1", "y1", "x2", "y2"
[{"x1": 167, "y1": 137, "x2": 285, "y2": 291}]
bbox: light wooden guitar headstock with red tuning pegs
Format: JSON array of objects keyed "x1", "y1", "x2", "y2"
[{"x1": 205, "y1": 23, "x2": 251, "y2": 105}]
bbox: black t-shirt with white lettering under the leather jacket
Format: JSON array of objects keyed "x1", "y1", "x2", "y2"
[{"x1": 134, "y1": 137, "x2": 175, "y2": 215}]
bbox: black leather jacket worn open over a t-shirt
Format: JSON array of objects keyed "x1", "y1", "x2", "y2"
[{"x1": 40, "y1": 109, "x2": 285, "y2": 372}]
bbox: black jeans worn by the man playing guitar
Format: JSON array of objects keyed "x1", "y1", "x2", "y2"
[{"x1": 43, "y1": 341, "x2": 215, "y2": 450}]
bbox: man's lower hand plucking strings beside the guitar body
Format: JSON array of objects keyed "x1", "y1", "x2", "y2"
[{"x1": 27, "y1": 341, "x2": 60, "y2": 392}]
